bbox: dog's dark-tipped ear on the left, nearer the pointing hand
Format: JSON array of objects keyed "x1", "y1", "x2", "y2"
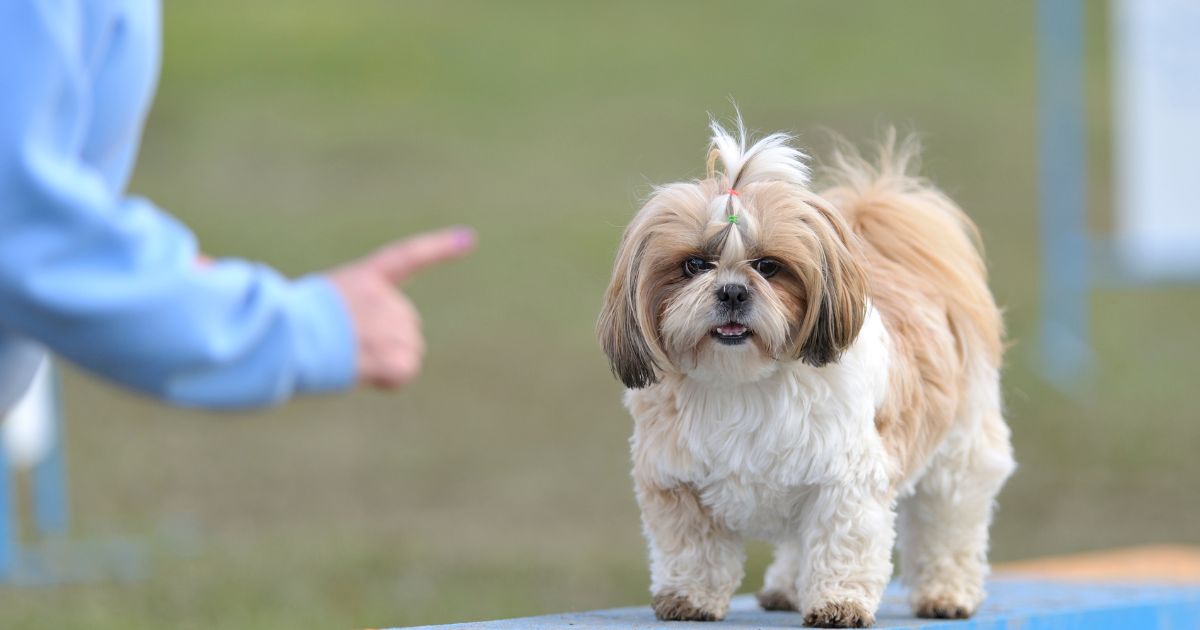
[{"x1": 596, "y1": 230, "x2": 659, "y2": 389}]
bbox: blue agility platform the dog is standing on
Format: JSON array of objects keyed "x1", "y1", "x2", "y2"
[{"x1": 393, "y1": 578, "x2": 1200, "y2": 630}]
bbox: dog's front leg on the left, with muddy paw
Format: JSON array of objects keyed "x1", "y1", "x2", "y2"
[{"x1": 637, "y1": 484, "x2": 745, "y2": 622}]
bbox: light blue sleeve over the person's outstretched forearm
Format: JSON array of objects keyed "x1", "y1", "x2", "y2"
[{"x1": 0, "y1": 202, "x2": 355, "y2": 407}]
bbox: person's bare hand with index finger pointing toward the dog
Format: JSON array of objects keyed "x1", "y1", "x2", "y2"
[{"x1": 328, "y1": 228, "x2": 475, "y2": 389}]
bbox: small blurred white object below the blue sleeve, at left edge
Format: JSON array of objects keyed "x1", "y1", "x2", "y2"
[{"x1": 2, "y1": 355, "x2": 55, "y2": 469}]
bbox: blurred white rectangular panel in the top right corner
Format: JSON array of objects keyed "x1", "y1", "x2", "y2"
[{"x1": 1112, "y1": 0, "x2": 1200, "y2": 280}]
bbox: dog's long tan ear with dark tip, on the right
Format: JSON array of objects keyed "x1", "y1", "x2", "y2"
[{"x1": 799, "y1": 198, "x2": 868, "y2": 367}]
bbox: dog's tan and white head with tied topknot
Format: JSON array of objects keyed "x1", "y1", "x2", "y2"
[{"x1": 599, "y1": 120, "x2": 866, "y2": 388}]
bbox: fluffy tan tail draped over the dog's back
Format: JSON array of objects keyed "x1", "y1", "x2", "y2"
[{"x1": 821, "y1": 130, "x2": 1003, "y2": 366}]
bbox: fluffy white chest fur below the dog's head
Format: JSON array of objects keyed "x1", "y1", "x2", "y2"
[{"x1": 626, "y1": 310, "x2": 893, "y2": 539}]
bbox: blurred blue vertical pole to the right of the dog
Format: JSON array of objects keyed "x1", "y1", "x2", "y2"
[{"x1": 1037, "y1": 0, "x2": 1091, "y2": 388}]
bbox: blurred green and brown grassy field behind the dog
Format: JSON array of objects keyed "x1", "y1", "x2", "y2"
[{"x1": 0, "y1": 0, "x2": 1200, "y2": 629}]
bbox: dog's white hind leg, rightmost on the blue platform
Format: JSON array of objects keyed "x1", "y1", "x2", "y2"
[{"x1": 899, "y1": 385, "x2": 1015, "y2": 619}]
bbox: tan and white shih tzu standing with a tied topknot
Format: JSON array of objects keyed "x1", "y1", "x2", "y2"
[{"x1": 599, "y1": 120, "x2": 1014, "y2": 628}]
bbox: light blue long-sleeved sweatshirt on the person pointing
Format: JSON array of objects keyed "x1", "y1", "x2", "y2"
[{"x1": 0, "y1": 0, "x2": 355, "y2": 409}]
